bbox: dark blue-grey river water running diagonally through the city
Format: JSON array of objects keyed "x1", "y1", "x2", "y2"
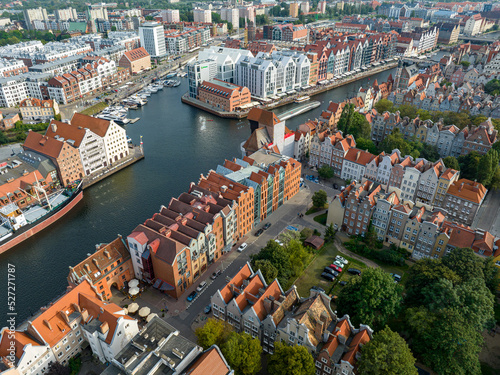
[{"x1": 0, "y1": 69, "x2": 395, "y2": 327}]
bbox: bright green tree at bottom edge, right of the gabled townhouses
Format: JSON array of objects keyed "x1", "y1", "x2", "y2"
[{"x1": 358, "y1": 327, "x2": 418, "y2": 375}]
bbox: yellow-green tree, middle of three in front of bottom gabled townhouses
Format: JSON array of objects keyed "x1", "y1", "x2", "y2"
[{"x1": 221, "y1": 332, "x2": 262, "y2": 375}]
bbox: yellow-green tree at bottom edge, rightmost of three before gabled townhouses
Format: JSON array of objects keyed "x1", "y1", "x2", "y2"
[{"x1": 267, "y1": 342, "x2": 315, "y2": 375}]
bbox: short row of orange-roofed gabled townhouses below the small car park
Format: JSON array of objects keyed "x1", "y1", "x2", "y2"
[{"x1": 211, "y1": 263, "x2": 373, "y2": 375}]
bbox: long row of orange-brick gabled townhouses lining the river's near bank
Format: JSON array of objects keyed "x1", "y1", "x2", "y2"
[{"x1": 68, "y1": 150, "x2": 301, "y2": 299}]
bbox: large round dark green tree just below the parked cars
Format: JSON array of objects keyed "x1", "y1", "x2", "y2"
[{"x1": 337, "y1": 268, "x2": 402, "y2": 328}]
